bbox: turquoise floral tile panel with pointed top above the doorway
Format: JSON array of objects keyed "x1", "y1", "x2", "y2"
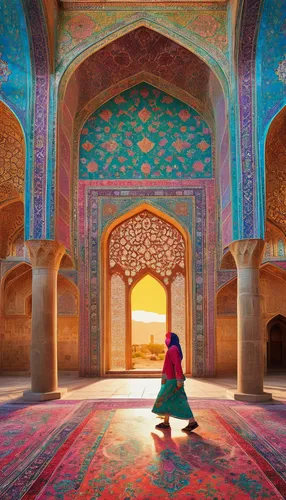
[{"x1": 79, "y1": 84, "x2": 213, "y2": 179}]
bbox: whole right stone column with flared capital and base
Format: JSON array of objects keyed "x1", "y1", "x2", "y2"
[{"x1": 228, "y1": 239, "x2": 272, "y2": 402}]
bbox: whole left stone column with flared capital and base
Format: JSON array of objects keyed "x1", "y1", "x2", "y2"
[{"x1": 24, "y1": 240, "x2": 66, "y2": 401}]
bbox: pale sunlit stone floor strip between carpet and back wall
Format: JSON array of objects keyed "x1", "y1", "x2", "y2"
[{"x1": 0, "y1": 373, "x2": 286, "y2": 403}]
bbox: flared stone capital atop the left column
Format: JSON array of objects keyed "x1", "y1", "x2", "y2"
[{"x1": 25, "y1": 240, "x2": 65, "y2": 270}]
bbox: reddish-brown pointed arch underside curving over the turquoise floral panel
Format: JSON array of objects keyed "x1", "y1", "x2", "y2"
[{"x1": 56, "y1": 26, "x2": 232, "y2": 256}]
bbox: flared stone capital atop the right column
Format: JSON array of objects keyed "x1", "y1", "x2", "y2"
[{"x1": 229, "y1": 239, "x2": 265, "y2": 269}]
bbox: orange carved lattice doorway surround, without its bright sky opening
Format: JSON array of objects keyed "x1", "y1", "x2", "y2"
[{"x1": 102, "y1": 204, "x2": 191, "y2": 374}]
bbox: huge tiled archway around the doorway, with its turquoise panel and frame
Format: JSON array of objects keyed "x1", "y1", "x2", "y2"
[{"x1": 66, "y1": 26, "x2": 219, "y2": 376}]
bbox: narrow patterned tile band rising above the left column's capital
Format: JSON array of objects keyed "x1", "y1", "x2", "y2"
[{"x1": 22, "y1": 0, "x2": 49, "y2": 239}]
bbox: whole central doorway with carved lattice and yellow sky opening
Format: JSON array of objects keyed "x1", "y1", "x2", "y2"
[{"x1": 101, "y1": 203, "x2": 192, "y2": 377}]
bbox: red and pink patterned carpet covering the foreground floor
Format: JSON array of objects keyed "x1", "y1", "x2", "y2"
[{"x1": 0, "y1": 399, "x2": 286, "y2": 500}]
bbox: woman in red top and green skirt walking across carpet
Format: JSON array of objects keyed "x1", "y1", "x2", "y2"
[{"x1": 152, "y1": 332, "x2": 199, "y2": 432}]
